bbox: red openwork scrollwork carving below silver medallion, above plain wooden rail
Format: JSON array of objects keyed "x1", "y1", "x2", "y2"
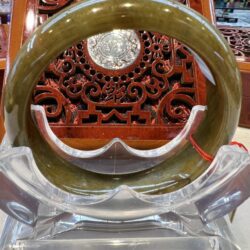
[{"x1": 34, "y1": 31, "x2": 206, "y2": 129}]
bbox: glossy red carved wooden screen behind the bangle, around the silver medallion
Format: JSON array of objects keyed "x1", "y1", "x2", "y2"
[{"x1": 20, "y1": 0, "x2": 206, "y2": 148}]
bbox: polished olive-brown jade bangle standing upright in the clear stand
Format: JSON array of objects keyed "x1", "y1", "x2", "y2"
[{"x1": 4, "y1": 0, "x2": 241, "y2": 194}]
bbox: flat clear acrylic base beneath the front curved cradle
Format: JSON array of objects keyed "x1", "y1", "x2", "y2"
[{"x1": 0, "y1": 216, "x2": 240, "y2": 250}]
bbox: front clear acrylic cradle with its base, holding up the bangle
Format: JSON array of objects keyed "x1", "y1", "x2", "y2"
[{"x1": 0, "y1": 106, "x2": 250, "y2": 250}]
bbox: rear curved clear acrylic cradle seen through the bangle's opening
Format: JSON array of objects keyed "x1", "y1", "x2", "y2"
[{"x1": 31, "y1": 105, "x2": 207, "y2": 175}]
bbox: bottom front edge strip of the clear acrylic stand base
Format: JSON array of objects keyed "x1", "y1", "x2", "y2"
[{"x1": 10, "y1": 237, "x2": 239, "y2": 250}]
